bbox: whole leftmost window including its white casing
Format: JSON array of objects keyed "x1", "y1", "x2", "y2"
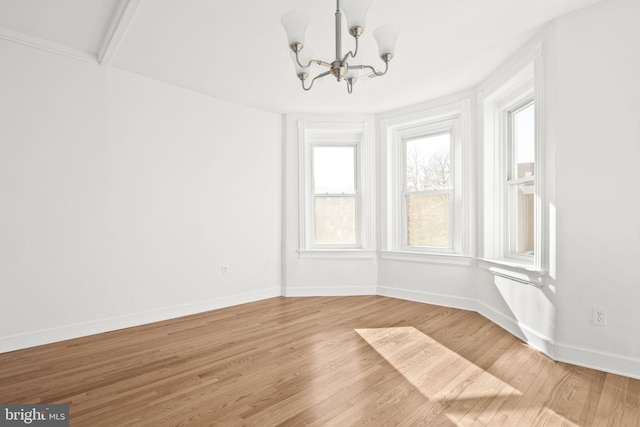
[{"x1": 298, "y1": 120, "x2": 375, "y2": 258}]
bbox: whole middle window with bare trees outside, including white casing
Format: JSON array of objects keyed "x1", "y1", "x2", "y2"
[{"x1": 381, "y1": 98, "x2": 475, "y2": 265}]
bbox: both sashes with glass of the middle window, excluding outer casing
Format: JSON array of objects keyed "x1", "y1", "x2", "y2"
[{"x1": 402, "y1": 132, "x2": 454, "y2": 249}]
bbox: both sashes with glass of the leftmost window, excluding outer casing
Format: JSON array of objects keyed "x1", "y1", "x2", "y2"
[{"x1": 311, "y1": 145, "x2": 359, "y2": 247}]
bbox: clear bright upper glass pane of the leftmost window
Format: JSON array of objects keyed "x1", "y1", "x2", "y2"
[{"x1": 313, "y1": 147, "x2": 355, "y2": 194}]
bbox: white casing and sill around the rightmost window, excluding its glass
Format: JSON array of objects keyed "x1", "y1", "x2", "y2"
[{"x1": 478, "y1": 44, "x2": 552, "y2": 280}]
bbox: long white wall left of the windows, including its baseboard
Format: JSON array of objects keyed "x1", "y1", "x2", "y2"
[{"x1": 0, "y1": 41, "x2": 282, "y2": 351}]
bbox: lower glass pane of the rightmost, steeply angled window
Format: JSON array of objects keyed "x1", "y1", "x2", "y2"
[{"x1": 511, "y1": 182, "x2": 535, "y2": 255}]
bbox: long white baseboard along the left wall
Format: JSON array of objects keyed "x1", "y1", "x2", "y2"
[{"x1": 0, "y1": 287, "x2": 282, "y2": 353}]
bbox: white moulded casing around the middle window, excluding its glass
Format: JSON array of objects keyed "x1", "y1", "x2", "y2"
[{"x1": 379, "y1": 97, "x2": 475, "y2": 260}]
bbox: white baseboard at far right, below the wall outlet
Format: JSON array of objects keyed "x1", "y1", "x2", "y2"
[{"x1": 554, "y1": 343, "x2": 640, "y2": 380}]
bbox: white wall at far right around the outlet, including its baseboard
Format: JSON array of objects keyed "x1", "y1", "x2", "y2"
[{"x1": 556, "y1": 0, "x2": 640, "y2": 377}]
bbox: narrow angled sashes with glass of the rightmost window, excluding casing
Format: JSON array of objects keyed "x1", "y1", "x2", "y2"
[{"x1": 505, "y1": 100, "x2": 536, "y2": 258}]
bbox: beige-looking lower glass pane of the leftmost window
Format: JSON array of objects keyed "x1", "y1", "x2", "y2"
[{"x1": 314, "y1": 196, "x2": 356, "y2": 245}]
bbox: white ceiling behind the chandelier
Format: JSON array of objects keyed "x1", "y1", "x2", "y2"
[{"x1": 0, "y1": 0, "x2": 601, "y2": 113}]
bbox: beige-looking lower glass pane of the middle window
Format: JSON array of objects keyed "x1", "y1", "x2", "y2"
[{"x1": 406, "y1": 193, "x2": 449, "y2": 248}]
